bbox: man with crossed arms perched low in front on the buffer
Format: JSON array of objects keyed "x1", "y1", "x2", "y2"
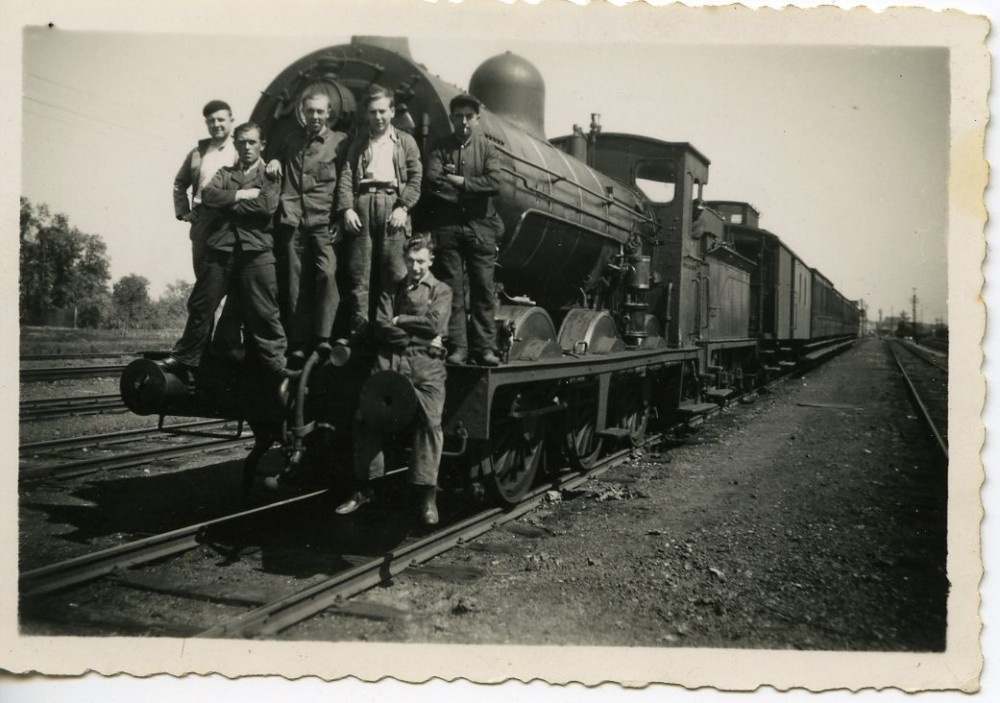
[{"x1": 337, "y1": 237, "x2": 451, "y2": 525}]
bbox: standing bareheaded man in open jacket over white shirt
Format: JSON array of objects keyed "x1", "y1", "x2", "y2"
[{"x1": 337, "y1": 86, "x2": 423, "y2": 332}]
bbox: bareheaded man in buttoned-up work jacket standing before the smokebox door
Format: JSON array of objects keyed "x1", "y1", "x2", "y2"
[{"x1": 267, "y1": 92, "x2": 347, "y2": 353}]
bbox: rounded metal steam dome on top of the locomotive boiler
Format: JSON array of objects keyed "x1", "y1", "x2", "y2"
[{"x1": 469, "y1": 51, "x2": 545, "y2": 141}]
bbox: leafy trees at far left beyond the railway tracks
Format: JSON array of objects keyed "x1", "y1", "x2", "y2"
[{"x1": 18, "y1": 196, "x2": 191, "y2": 333}]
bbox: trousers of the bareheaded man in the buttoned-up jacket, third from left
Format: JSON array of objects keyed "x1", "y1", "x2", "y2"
[{"x1": 278, "y1": 224, "x2": 340, "y2": 348}]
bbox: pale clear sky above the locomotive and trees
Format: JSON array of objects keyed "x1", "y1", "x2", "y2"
[{"x1": 13, "y1": 0, "x2": 950, "y2": 322}]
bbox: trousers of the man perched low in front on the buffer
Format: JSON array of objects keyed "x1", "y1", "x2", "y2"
[{"x1": 354, "y1": 350, "x2": 447, "y2": 486}]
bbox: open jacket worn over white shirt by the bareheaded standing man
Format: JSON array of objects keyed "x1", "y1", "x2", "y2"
[{"x1": 337, "y1": 125, "x2": 424, "y2": 214}]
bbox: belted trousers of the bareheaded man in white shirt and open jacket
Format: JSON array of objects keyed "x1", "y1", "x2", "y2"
[{"x1": 344, "y1": 193, "x2": 410, "y2": 322}]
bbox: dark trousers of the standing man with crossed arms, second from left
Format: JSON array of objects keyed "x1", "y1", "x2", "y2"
[{"x1": 173, "y1": 245, "x2": 287, "y2": 371}]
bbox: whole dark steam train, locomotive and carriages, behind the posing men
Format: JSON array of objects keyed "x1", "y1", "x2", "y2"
[{"x1": 121, "y1": 38, "x2": 858, "y2": 503}]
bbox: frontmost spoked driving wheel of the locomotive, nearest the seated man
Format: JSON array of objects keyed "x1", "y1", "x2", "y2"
[{"x1": 486, "y1": 417, "x2": 545, "y2": 504}]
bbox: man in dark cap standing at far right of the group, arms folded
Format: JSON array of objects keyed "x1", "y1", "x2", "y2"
[{"x1": 423, "y1": 95, "x2": 503, "y2": 366}]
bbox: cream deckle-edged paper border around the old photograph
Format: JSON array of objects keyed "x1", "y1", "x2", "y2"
[{"x1": 0, "y1": 0, "x2": 996, "y2": 699}]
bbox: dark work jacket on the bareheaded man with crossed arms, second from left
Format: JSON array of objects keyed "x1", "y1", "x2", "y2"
[{"x1": 201, "y1": 159, "x2": 281, "y2": 251}]
